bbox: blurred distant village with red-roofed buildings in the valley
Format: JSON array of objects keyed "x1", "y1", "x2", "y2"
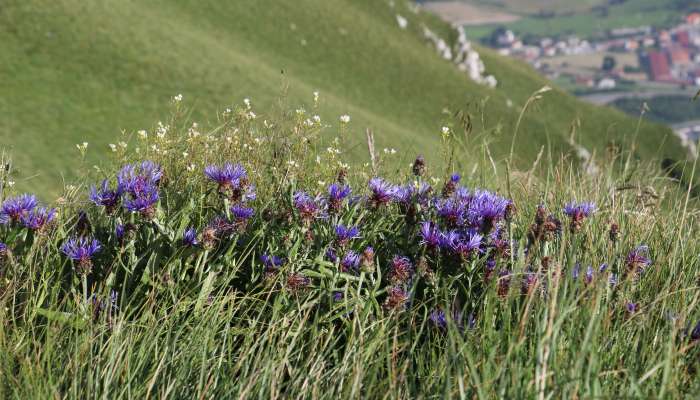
[{"x1": 489, "y1": 13, "x2": 700, "y2": 90}]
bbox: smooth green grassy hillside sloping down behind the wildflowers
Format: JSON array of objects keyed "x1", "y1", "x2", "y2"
[{"x1": 0, "y1": 0, "x2": 682, "y2": 194}]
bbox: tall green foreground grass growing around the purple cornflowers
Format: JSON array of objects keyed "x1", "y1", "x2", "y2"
[{"x1": 0, "y1": 95, "x2": 700, "y2": 399}]
